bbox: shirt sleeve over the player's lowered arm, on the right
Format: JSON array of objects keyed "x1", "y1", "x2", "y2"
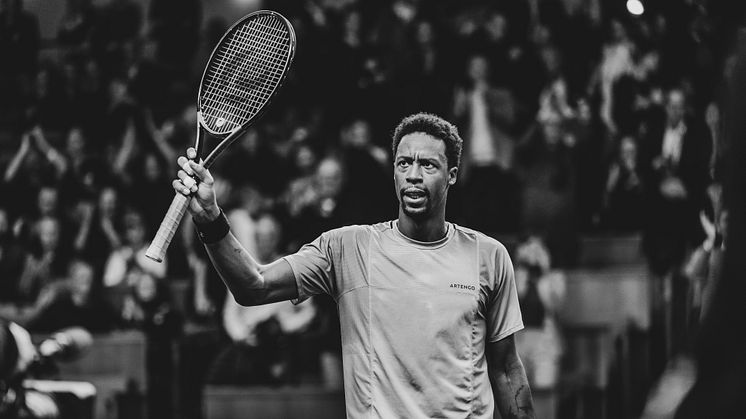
[{"x1": 487, "y1": 247, "x2": 523, "y2": 342}]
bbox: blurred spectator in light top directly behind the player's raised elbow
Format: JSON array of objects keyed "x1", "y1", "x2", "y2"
[{"x1": 207, "y1": 215, "x2": 316, "y2": 385}]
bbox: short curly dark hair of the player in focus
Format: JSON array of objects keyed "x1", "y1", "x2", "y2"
[{"x1": 391, "y1": 112, "x2": 464, "y2": 169}]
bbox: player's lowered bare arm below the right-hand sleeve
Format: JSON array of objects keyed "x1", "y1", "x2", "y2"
[{"x1": 487, "y1": 335, "x2": 534, "y2": 419}]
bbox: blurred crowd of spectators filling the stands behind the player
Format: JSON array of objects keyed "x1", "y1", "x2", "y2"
[{"x1": 0, "y1": 0, "x2": 737, "y2": 418}]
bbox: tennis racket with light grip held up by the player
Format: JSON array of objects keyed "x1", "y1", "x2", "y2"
[{"x1": 145, "y1": 10, "x2": 295, "y2": 262}]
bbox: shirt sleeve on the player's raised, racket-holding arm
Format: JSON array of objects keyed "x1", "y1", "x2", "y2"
[{"x1": 284, "y1": 231, "x2": 340, "y2": 304}]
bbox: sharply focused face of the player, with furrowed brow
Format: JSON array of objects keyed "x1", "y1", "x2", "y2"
[{"x1": 394, "y1": 132, "x2": 458, "y2": 219}]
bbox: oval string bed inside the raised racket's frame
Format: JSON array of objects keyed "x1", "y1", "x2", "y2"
[{"x1": 200, "y1": 16, "x2": 290, "y2": 133}]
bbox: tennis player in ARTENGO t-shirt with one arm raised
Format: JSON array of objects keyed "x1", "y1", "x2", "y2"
[{"x1": 173, "y1": 114, "x2": 534, "y2": 419}]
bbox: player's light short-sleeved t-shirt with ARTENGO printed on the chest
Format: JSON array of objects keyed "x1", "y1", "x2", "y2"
[{"x1": 285, "y1": 221, "x2": 523, "y2": 419}]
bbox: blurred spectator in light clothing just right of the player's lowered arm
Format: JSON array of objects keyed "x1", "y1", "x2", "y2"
[{"x1": 515, "y1": 237, "x2": 565, "y2": 388}]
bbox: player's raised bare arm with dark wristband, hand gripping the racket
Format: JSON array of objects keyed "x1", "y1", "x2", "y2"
[{"x1": 173, "y1": 148, "x2": 298, "y2": 305}]
